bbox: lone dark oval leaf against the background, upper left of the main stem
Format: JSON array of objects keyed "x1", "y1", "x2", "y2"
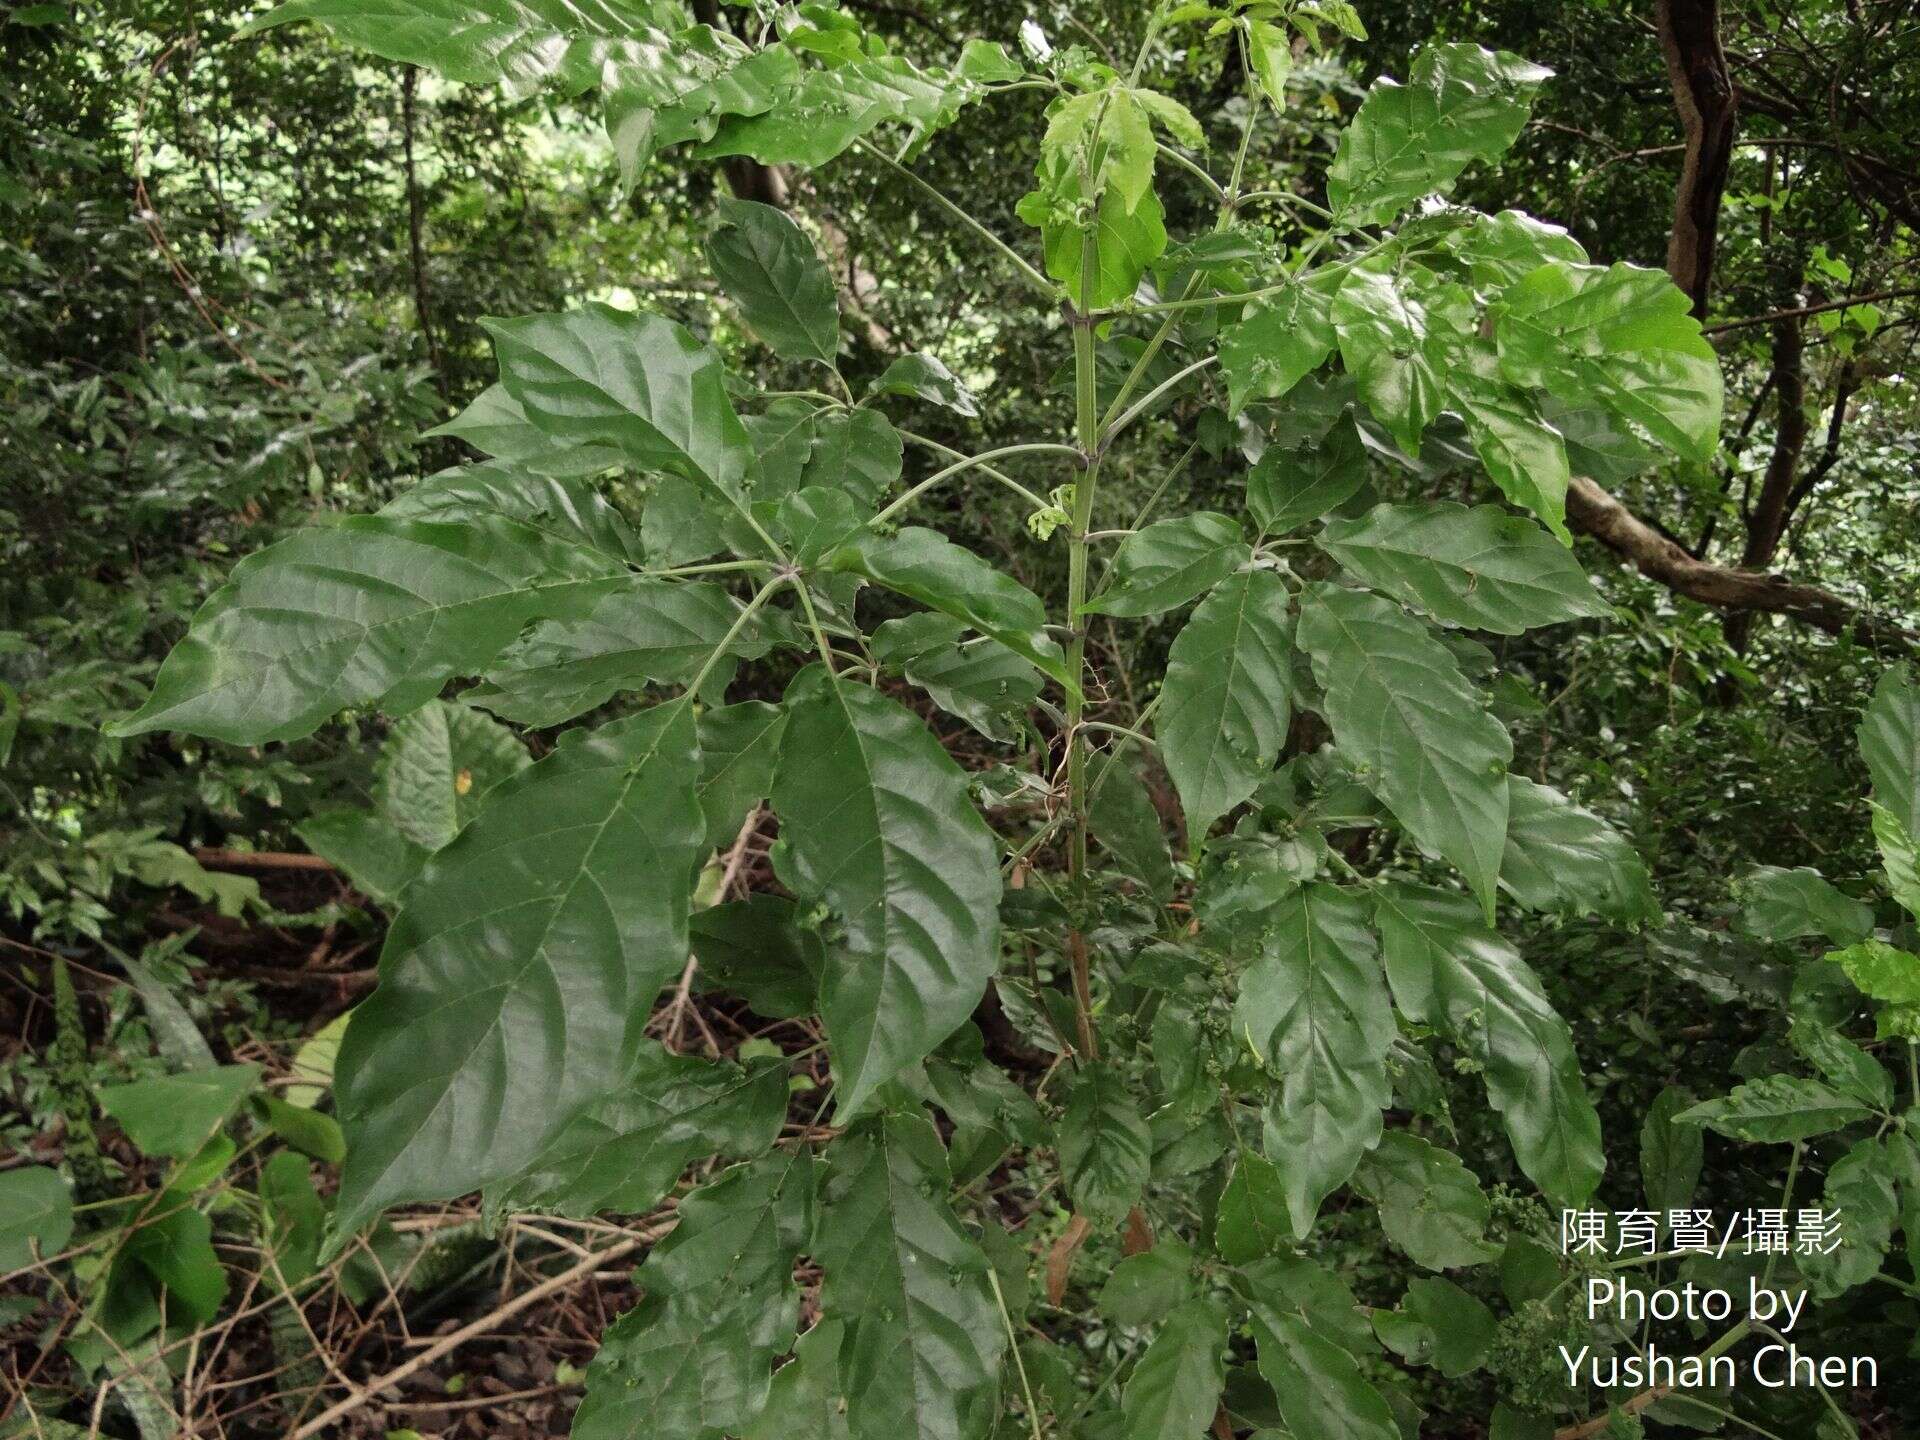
[{"x1": 707, "y1": 196, "x2": 839, "y2": 365}]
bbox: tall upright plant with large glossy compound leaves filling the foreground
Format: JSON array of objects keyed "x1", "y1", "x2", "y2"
[{"x1": 97, "y1": 0, "x2": 1743, "y2": 1440}]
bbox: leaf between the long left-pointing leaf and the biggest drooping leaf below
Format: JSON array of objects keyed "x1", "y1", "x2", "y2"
[{"x1": 467, "y1": 576, "x2": 772, "y2": 725}]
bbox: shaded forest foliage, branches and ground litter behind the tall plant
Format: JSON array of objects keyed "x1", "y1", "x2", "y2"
[{"x1": 11, "y1": 0, "x2": 1920, "y2": 1440}]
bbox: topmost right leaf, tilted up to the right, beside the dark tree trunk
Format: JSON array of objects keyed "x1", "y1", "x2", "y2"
[{"x1": 1327, "y1": 44, "x2": 1553, "y2": 225}]
